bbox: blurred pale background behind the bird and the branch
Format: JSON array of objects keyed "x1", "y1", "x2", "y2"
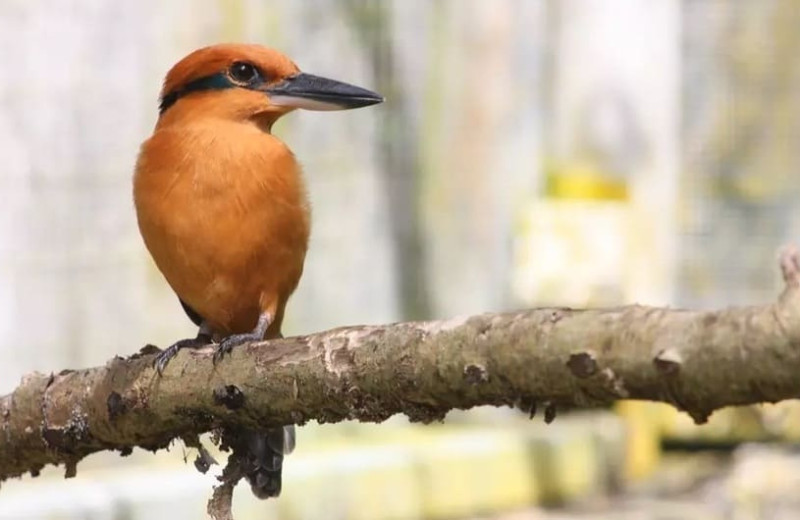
[{"x1": 0, "y1": 0, "x2": 800, "y2": 520}]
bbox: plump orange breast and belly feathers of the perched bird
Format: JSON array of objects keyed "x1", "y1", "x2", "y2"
[{"x1": 134, "y1": 118, "x2": 310, "y2": 335}]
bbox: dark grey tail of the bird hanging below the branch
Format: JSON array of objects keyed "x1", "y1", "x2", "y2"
[{"x1": 243, "y1": 425, "x2": 295, "y2": 498}]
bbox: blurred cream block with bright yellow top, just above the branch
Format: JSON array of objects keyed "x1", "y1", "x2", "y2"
[{"x1": 511, "y1": 161, "x2": 636, "y2": 307}]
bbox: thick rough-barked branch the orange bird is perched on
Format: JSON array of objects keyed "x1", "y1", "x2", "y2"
[{"x1": 0, "y1": 249, "x2": 800, "y2": 506}]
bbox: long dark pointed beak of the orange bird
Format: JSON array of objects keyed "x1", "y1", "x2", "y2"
[{"x1": 266, "y1": 72, "x2": 383, "y2": 110}]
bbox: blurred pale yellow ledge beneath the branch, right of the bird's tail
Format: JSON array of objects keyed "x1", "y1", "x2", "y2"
[{"x1": 235, "y1": 411, "x2": 625, "y2": 520}]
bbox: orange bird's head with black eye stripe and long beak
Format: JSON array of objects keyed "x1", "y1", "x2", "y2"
[{"x1": 159, "y1": 44, "x2": 383, "y2": 128}]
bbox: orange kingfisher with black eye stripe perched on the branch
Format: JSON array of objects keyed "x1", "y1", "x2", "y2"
[{"x1": 133, "y1": 43, "x2": 384, "y2": 498}]
